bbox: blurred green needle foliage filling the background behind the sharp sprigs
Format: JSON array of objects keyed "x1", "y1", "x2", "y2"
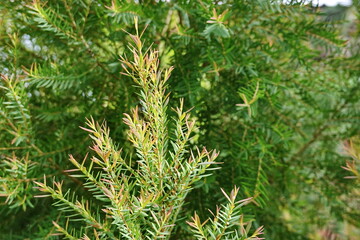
[{"x1": 0, "y1": 0, "x2": 360, "y2": 239}]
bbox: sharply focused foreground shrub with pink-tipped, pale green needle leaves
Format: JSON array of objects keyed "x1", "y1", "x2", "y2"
[{"x1": 36, "y1": 24, "x2": 262, "y2": 240}]
